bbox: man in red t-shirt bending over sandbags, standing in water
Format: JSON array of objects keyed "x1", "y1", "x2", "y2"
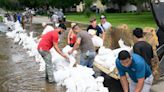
[{"x1": 38, "y1": 26, "x2": 68, "y2": 83}]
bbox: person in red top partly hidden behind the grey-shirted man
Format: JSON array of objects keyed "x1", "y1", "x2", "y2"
[{"x1": 67, "y1": 23, "x2": 76, "y2": 47}]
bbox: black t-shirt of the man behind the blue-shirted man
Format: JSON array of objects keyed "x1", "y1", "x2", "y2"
[{"x1": 133, "y1": 41, "x2": 153, "y2": 68}]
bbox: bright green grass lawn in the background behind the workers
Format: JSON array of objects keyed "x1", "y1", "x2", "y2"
[{"x1": 66, "y1": 12, "x2": 156, "y2": 28}]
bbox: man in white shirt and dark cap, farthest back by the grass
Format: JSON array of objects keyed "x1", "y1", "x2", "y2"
[{"x1": 99, "y1": 15, "x2": 112, "y2": 32}]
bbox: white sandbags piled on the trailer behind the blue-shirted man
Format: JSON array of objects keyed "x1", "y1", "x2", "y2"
[{"x1": 95, "y1": 39, "x2": 132, "y2": 71}]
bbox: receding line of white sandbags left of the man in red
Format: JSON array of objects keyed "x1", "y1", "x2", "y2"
[{"x1": 5, "y1": 21, "x2": 42, "y2": 61}]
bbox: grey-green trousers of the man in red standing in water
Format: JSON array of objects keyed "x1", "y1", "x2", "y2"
[{"x1": 38, "y1": 50, "x2": 54, "y2": 82}]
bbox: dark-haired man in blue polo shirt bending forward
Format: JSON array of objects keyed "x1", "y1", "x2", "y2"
[{"x1": 116, "y1": 50, "x2": 153, "y2": 92}]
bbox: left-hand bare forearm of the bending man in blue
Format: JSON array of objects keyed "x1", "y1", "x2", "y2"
[{"x1": 120, "y1": 75, "x2": 129, "y2": 92}]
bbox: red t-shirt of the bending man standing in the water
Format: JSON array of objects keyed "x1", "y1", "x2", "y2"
[{"x1": 38, "y1": 29, "x2": 58, "y2": 51}]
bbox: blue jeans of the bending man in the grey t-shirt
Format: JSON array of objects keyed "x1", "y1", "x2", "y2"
[{"x1": 80, "y1": 51, "x2": 96, "y2": 68}]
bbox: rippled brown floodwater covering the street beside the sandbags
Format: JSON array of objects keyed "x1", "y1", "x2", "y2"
[{"x1": 0, "y1": 23, "x2": 66, "y2": 92}]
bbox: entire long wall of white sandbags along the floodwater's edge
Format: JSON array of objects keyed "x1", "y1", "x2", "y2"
[{"x1": 6, "y1": 18, "x2": 108, "y2": 92}]
